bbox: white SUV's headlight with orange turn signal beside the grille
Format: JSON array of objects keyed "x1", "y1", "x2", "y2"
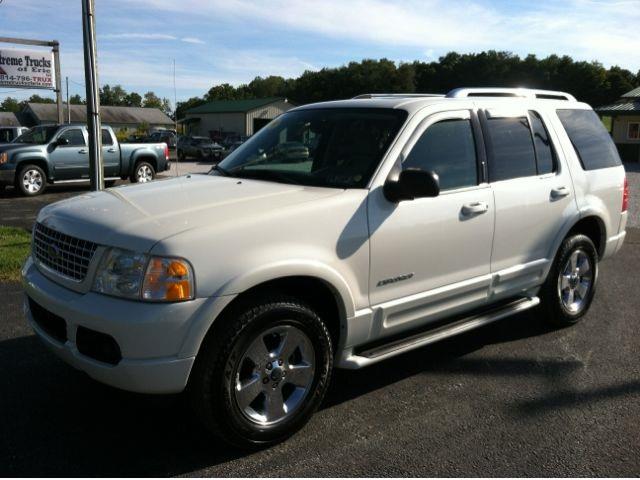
[{"x1": 93, "y1": 248, "x2": 194, "y2": 302}]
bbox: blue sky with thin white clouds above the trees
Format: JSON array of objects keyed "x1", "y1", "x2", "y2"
[{"x1": 0, "y1": 0, "x2": 640, "y2": 109}]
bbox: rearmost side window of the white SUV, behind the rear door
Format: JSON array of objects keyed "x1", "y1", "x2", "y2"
[{"x1": 557, "y1": 110, "x2": 621, "y2": 170}]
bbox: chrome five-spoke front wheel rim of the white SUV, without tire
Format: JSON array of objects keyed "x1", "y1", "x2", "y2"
[{"x1": 234, "y1": 325, "x2": 315, "y2": 425}]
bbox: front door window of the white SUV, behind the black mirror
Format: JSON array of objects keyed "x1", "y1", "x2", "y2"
[{"x1": 403, "y1": 119, "x2": 478, "y2": 190}]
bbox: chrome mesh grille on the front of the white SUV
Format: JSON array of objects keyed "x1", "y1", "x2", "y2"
[{"x1": 33, "y1": 223, "x2": 98, "y2": 281}]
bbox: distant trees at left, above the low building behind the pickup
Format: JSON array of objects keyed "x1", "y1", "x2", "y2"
[{"x1": 0, "y1": 85, "x2": 173, "y2": 116}]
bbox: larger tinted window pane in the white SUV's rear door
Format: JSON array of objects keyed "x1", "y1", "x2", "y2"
[{"x1": 487, "y1": 117, "x2": 537, "y2": 182}]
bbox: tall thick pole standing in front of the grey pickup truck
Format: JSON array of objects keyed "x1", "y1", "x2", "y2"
[{"x1": 82, "y1": 0, "x2": 104, "y2": 190}]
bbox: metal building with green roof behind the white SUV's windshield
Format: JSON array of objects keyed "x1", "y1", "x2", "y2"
[{"x1": 178, "y1": 97, "x2": 295, "y2": 139}]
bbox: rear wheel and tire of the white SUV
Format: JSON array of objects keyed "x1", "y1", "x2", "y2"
[{"x1": 540, "y1": 235, "x2": 598, "y2": 327}]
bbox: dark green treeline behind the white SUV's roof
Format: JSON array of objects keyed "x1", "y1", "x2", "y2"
[{"x1": 177, "y1": 51, "x2": 640, "y2": 118}]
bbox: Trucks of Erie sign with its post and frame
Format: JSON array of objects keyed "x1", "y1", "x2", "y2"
[{"x1": 0, "y1": 37, "x2": 64, "y2": 123}]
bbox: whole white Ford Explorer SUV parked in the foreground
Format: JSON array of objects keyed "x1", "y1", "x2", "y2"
[{"x1": 22, "y1": 89, "x2": 628, "y2": 446}]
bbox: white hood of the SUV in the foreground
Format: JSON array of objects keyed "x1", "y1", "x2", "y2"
[{"x1": 38, "y1": 175, "x2": 342, "y2": 252}]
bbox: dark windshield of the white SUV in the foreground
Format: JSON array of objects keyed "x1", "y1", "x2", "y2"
[{"x1": 211, "y1": 108, "x2": 407, "y2": 188}]
